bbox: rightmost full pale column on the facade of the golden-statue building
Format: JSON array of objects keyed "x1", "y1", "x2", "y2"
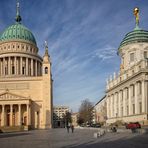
[{"x1": 142, "y1": 80, "x2": 146, "y2": 113}]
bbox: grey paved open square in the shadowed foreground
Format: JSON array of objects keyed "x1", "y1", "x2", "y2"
[{"x1": 0, "y1": 129, "x2": 148, "y2": 148}]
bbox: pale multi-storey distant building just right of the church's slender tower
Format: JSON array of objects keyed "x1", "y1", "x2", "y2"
[{"x1": 53, "y1": 105, "x2": 70, "y2": 127}]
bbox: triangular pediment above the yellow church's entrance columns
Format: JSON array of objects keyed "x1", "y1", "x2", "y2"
[{"x1": 0, "y1": 91, "x2": 28, "y2": 100}]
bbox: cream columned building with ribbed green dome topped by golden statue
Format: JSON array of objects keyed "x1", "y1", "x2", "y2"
[{"x1": 106, "y1": 8, "x2": 148, "y2": 125}]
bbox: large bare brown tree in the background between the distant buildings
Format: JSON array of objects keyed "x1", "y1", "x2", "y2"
[{"x1": 78, "y1": 99, "x2": 93, "y2": 124}]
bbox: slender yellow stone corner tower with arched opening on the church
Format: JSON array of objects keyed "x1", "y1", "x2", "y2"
[{"x1": 42, "y1": 41, "x2": 53, "y2": 128}]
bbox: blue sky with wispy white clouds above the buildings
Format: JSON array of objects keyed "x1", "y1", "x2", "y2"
[{"x1": 0, "y1": 0, "x2": 148, "y2": 112}]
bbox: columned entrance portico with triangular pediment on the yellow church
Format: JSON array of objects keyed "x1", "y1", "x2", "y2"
[{"x1": 0, "y1": 92, "x2": 31, "y2": 127}]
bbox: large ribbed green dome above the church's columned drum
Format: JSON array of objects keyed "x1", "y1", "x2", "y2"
[{"x1": 0, "y1": 22, "x2": 36, "y2": 45}]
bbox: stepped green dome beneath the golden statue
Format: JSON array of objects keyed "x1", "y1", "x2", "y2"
[{"x1": 119, "y1": 27, "x2": 148, "y2": 49}]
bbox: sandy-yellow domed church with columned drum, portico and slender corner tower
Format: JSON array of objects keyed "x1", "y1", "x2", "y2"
[{"x1": 0, "y1": 2, "x2": 52, "y2": 130}]
